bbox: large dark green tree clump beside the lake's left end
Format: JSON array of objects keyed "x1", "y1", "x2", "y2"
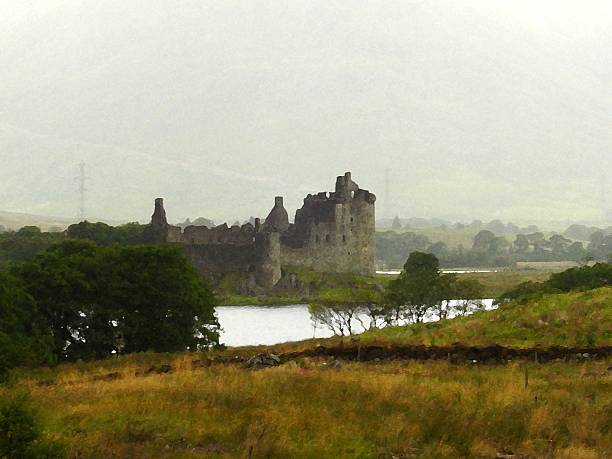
[{"x1": 14, "y1": 240, "x2": 218, "y2": 359}]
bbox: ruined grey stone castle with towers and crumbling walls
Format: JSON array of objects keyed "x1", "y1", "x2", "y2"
[{"x1": 146, "y1": 172, "x2": 376, "y2": 288}]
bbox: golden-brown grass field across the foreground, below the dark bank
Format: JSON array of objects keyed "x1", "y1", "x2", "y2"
[{"x1": 3, "y1": 355, "x2": 612, "y2": 458}]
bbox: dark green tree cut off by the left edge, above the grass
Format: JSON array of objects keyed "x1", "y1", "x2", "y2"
[{"x1": 0, "y1": 272, "x2": 54, "y2": 382}]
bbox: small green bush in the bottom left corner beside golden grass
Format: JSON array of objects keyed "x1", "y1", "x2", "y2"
[{"x1": 0, "y1": 394, "x2": 66, "y2": 459}]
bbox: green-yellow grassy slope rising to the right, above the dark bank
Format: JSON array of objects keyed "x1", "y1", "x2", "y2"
[{"x1": 360, "y1": 287, "x2": 612, "y2": 348}]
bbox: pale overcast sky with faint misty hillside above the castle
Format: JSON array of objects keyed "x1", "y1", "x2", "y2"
[{"x1": 0, "y1": 0, "x2": 612, "y2": 223}]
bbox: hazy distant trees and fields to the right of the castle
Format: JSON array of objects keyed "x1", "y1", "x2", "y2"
[{"x1": 376, "y1": 229, "x2": 612, "y2": 268}]
